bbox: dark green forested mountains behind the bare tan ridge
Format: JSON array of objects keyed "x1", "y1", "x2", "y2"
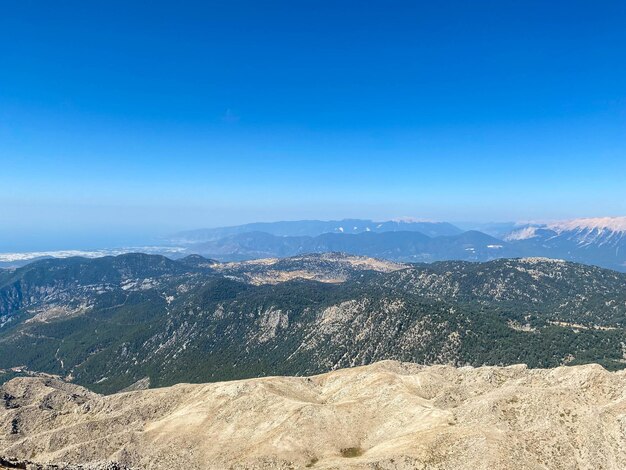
[{"x1": 0, "y1": 253, "x2": 626, "y2": 393}]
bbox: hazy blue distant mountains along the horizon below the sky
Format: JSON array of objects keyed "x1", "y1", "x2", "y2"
[{"x1": 168, "y1": 217, "x2": 626, "y2": 271}]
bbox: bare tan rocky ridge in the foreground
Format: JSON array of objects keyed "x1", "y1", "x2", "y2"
[{"x1": 0, "y1": 361, "x2": 626, "y2": 470}]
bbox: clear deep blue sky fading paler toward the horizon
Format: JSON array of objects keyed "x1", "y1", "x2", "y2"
[{"x1": 0, "y1": 0, "x2": 626, "y2": 251}]
